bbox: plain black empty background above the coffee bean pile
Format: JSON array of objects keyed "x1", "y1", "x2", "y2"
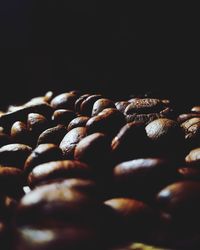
[{"x1": 0, "y1": 0, "x2": 200, "y2": 109}]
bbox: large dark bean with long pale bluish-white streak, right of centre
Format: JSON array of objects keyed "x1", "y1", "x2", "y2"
[{"x1": 113, "y1": 158, "x2": 177, "y2": 200}]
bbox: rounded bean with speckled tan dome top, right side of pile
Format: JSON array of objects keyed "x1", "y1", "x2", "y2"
[{"x1": 145, "y1": 118, "x2": 185, "y2": 159}]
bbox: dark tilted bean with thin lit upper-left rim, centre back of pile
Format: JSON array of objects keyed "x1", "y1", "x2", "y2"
[{"x1": 86, "y1": 108, "x2": 126, "y2": 137}]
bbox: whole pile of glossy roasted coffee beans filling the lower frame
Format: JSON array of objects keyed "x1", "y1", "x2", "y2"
[{"x1": 0, "y1": 90, "x2": 200, "y2": 250}]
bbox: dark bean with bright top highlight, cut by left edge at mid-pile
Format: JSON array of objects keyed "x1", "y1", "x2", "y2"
[{"x1": 0, "y1": 143, "x2": 32, "y2": 168}]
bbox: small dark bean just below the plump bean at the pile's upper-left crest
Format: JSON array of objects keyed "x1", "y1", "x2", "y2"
[{"x1": 52, "y1": 109, "x2": 76, "y2": 125}]
